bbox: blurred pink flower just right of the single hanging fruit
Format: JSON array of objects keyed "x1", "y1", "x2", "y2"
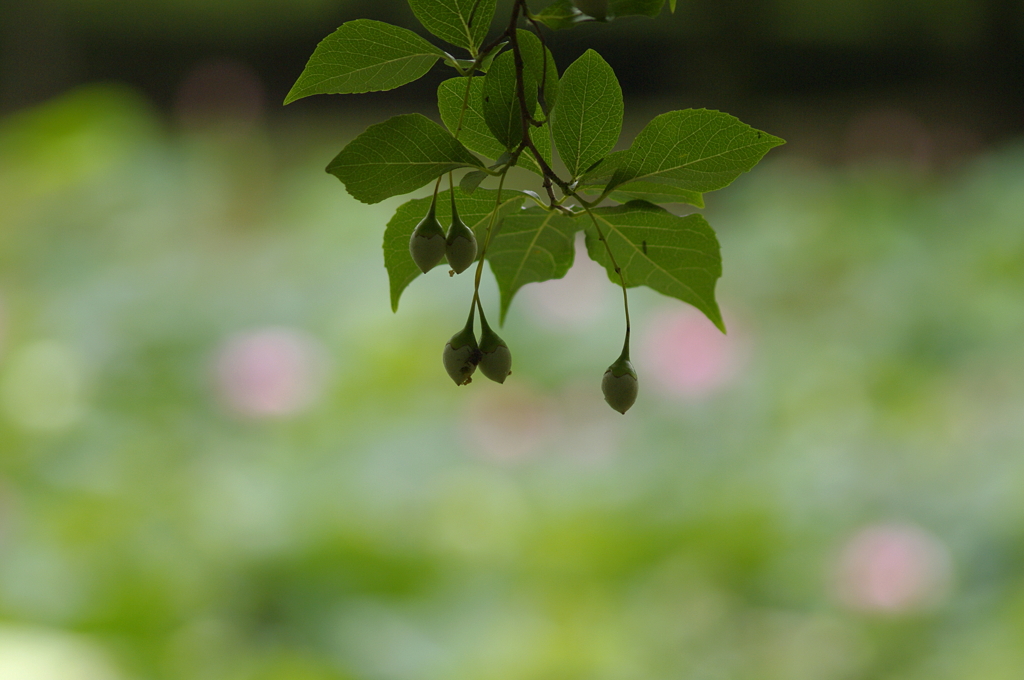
[{"x1": 634, "y1": 308, "x2": 739, "y2": 397}]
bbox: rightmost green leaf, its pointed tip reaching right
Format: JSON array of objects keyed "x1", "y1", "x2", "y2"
[{"x1": 584, "y1": 109, "x2": 785, "y2": 194}]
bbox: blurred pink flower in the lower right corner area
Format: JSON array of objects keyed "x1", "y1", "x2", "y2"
[{"x1": 836, "y1": 523, "x2": 951, "y2": 614}]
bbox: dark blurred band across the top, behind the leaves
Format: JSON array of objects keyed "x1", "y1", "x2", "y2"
[{"x1": 6, "y1": 0, "x2": 1024, "y2": 155}]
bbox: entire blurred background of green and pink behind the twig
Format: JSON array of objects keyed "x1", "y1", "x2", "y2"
[{"x1": 0, "y1": 0, "x2": 1024, "y2": 680}]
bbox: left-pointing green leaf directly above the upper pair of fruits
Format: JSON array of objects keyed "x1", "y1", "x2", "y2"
[{"x1": 327, "y1": 114, "x2": 483, "y2": 203}]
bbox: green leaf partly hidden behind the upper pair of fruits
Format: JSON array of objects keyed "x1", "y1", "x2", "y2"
[{"x1": 384, "y1": 188, "x2": 523, "y2": 311}]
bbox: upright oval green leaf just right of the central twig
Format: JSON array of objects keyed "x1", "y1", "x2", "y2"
[{"x1": 551, "y1": 49, "x2": 623, "y2": 177}]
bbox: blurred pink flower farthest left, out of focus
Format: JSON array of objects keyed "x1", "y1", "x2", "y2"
[{"x1": 216, "y1": 328, "x2": 326, "y2": 418}]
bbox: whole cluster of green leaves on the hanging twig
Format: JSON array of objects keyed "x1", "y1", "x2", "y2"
[{"x1": 285, "y1": 0, "x2": 783, "y2": 409}]
